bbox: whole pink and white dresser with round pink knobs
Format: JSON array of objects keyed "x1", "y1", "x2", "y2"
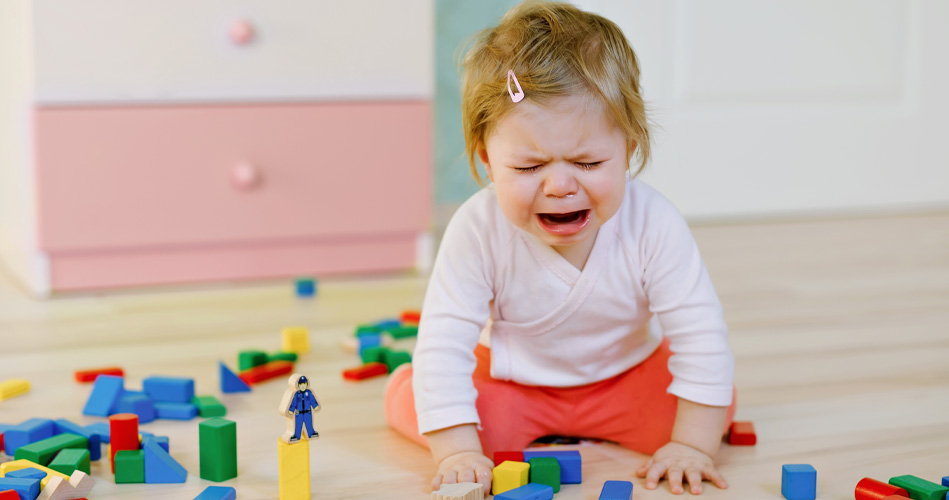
[{"x1": 0, "y1": 0, "x2": 433, "y2": 294}]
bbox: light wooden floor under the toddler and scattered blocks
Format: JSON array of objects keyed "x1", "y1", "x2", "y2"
[{"x1": 0, "y1": 214, "x2": 949, "y2": 500}]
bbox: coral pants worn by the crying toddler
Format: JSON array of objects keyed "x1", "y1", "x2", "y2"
[{"x1": 385, "y1": 341, "x2": 735, "y2": 457}]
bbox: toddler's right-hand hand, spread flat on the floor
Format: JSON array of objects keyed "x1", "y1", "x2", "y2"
[{"x1": 636, "y1": 442, "x2": 728, "y2": 495}]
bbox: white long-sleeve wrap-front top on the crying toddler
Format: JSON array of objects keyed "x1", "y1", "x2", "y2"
[{"x1": 412, "y1": 180, "x2": 734, "y2": 434}]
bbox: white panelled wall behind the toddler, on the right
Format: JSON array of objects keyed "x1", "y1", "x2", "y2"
[{"x1": 577, "y1": 0, "x2": 949, "y2": 220}]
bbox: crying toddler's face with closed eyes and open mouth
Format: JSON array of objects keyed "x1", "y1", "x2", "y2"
[{"x1": 479, "y1": 96, "x2": 628, "y2": 261}]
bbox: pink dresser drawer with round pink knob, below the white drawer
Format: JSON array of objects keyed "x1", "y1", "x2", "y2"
[{"x1": 35, "y1": 101, "x2": 432, "y2": 253}]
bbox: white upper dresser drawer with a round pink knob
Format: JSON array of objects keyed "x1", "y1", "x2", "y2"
[{"x1": 33, "y1": 0, "x2": 434, "y2": 104}]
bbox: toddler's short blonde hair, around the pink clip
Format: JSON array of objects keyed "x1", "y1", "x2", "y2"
[{"x1": 461, "y1": 0, "x2": 649, "y2": 185}]
